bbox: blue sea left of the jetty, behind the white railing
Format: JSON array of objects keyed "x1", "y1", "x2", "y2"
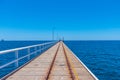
[{"x1": 0, "y1": 41, "x2": 48, "y2": 78}]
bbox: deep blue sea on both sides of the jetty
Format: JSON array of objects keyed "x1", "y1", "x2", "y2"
[{"x1": 0, "y1": 41, "x2": 120, "y2": 80}]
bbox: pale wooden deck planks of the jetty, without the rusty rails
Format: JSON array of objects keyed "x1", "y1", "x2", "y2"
[{"x1": 6, "y1": 42, "x2": 95, "y2": 80}]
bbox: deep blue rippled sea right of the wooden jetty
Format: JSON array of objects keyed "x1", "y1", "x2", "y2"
[{"x1": 65, "y1": 41, "x2": 120, "y2": 80}]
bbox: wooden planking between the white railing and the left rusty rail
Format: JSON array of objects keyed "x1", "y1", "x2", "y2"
[{"x1": 6, "y1": 43, "x2": 59, "y2": 80}]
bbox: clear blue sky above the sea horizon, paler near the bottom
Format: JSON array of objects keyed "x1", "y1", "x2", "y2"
[{"x1": 0, "y1": 0, "x2": 120, "y2": 40}]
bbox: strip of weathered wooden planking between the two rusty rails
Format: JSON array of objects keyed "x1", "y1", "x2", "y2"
[{"x1": 49, "y1": 44, "x2": 72, "y2": 80}]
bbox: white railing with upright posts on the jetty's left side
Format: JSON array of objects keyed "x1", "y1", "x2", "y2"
[{"x1": 0, "y1": 42, "x2": 54, "y2": 69}]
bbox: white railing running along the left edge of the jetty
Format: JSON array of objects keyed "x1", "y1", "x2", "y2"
[{"x1": 0, "y1": 41, "x2": 57, "y2": 78}]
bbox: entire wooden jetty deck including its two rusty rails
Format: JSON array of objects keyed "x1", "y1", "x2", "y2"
[{"x1": 2, "y1": 41, "x2": 98, "y2": 80}]
